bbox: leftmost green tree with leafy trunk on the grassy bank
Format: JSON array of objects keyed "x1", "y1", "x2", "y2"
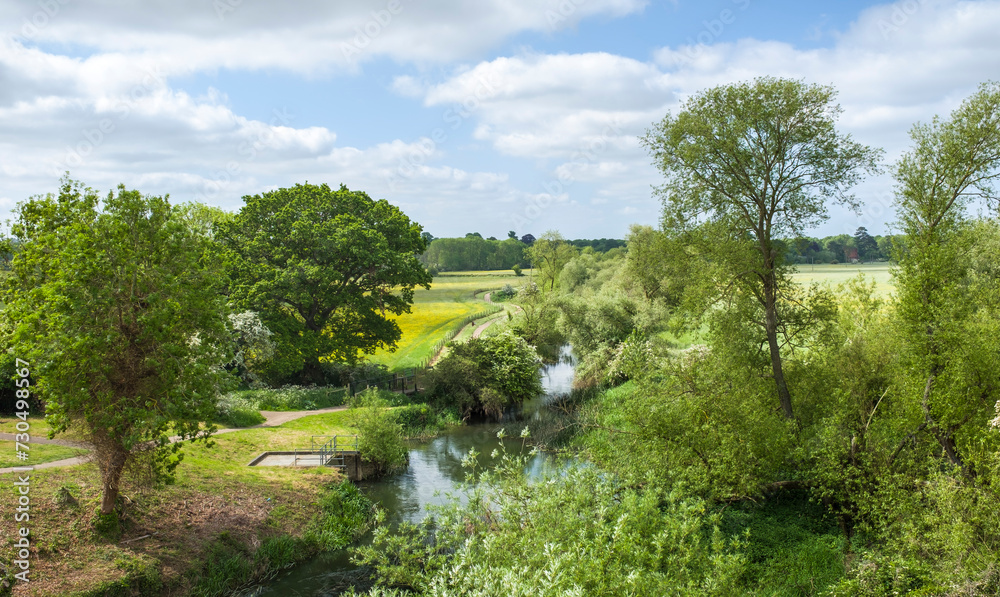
[{"x1": 4, "y1": 178, "x2": 231, "y2": 514}]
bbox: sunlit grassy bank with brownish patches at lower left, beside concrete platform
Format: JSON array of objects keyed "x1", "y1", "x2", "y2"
[{"x1": 0, "y1": 412, "x2": 355, "y2": 595}]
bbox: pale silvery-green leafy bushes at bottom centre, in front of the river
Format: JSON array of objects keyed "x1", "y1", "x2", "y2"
[{"x1": 355, "y1": 434, "x2": 742, "y2": 596}]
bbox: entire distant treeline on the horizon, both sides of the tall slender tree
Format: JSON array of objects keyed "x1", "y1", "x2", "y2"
[{"x1": 420, "y1": 226, "x2": 903, "y2": 271}]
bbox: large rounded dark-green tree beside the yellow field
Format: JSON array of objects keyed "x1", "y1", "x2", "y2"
[{"x1": 216, "y1": 183, "x2": 431, "y2": 383}]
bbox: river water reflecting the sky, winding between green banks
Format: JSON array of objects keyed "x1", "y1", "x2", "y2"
[{"x1": 254, "y1": 346, "x2": 575, "y2": 597}]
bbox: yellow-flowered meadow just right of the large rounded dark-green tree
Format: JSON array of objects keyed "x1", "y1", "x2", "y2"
[{"x1": 368, "y1": 270, "x2": 531, "y2": 370}]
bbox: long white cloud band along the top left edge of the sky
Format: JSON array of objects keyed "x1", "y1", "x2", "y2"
[{"x1": 0, "y1": 0, "x2": 645, "y2": 74}]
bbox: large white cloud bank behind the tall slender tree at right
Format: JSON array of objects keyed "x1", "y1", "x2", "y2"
[{"x1": 404, "y1": 0, "x2": 1000, "y2": 233}]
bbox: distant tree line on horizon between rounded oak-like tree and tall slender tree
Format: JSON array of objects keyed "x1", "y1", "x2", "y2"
[{"x1": 420, "y1": 230, "x2": 625, "y2": 271}]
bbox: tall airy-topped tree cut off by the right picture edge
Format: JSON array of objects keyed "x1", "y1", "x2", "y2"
[{"x1": 894, "y1": 83, "x2": 1000, "y2": 470}]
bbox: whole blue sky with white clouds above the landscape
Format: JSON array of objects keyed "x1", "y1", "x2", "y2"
[{"x1": 0, "y1": 0, "x2": 1000, "y2": 238}]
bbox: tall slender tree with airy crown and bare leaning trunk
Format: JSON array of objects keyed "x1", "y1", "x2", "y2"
[{"x1": 642, "y1": 78, "x2": 880, "y2": 418}]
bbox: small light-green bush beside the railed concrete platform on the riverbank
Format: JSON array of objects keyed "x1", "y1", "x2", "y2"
[{"x1": 352, "y1": 390, "x2": 407, "y2": 476}]
